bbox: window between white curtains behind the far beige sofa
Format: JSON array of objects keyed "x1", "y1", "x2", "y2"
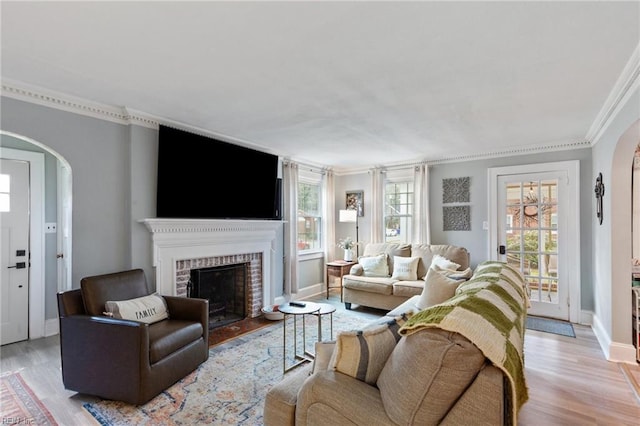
[{"x1": 384, "y1": 171, "x2": 413, "y2": 243}]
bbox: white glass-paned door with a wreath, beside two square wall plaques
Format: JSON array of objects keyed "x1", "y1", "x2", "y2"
[{"x1": 491, "y1": 162, "x2": 580, "y2": 321}]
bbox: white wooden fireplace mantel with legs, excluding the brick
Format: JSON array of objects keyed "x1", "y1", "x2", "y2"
[{"x1": 140, "y1": 219, "x2": 283, "y2": 306}]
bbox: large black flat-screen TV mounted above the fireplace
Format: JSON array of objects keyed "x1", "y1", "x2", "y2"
[{"x1": 156, "y1": 125, "x2": 281, "y2": 220}]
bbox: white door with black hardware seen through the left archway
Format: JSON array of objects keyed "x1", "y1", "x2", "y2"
[{"x1": 0, "y1": 159, "x2": 30, "y2": 345}]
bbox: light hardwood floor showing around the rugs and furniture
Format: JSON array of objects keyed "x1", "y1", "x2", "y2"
[{"x1": 0, "y1": 294, "x2": 640, "y2": 426}]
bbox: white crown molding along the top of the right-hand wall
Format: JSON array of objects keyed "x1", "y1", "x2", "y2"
[{"x1": 585, "y1": 43, "x2": 640, "y2": 146}]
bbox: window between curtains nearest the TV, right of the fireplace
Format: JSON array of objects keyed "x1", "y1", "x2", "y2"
[{"x1": 298, "y1": 173, "x2": 322, "y2": 252}]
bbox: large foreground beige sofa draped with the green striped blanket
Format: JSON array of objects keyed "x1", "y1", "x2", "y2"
[{"x1": 263, "y1": 262, "x2": 528, "y2": 426}]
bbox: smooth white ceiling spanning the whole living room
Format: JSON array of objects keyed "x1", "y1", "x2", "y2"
[{"x1": 0, "y1": 1, "x2": 640, "y2": 170}]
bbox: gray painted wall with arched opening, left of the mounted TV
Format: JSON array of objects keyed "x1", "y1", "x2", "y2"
[{"x1": 0, "y1": 97, "x2": 283, "y2": 319}]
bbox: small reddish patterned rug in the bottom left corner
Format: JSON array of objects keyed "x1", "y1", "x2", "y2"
[{"x1": 0, "y1": 373, "x2": 58, "y2": 426}]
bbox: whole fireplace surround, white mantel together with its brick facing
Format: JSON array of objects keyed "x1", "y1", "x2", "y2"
[{"x1": 142, "y1": 219, "x2": 282, "y2": 318}]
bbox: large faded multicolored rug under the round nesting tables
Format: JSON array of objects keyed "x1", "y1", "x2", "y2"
[{"x1": 84, "y1": 312, "x2": 370, "y2": 426}]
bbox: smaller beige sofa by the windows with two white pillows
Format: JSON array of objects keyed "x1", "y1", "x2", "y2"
[{"x1": 342, "y1": 243, "x2": 469, "y2": 310}]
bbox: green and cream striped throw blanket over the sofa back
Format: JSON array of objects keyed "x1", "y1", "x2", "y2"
[{"x1": 400, "y1": 261, "x2": 529, "y2": 425}]
